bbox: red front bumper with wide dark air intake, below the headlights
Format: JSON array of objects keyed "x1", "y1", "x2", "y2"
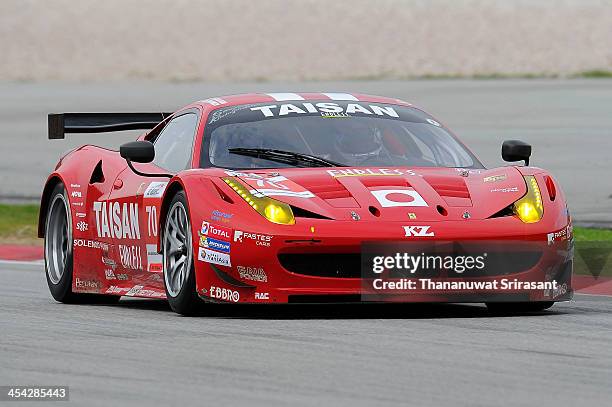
[{"x1": 195, "y1": 219, "x2": 573, "y2": 303}]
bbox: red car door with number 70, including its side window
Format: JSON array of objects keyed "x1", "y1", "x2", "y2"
[{"x1": 109, "y1": 111, "x2": 199, "y2": 295}]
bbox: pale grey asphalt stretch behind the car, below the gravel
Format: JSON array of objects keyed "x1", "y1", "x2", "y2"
[{"x1": 0, "y1": 79, "x2": 612, "y2": 226}]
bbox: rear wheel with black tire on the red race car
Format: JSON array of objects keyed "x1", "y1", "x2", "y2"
[{"x1": 44, "y1": 183, "x2": 120, "y2": 304}]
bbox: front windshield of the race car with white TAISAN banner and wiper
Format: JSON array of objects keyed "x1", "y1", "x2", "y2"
[{"x1": 201, "y1": 101, "x2": 482, "y2": 169}]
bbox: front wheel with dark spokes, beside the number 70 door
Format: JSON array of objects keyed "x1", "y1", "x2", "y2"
[{"x1": 162, "y1": 191, "x2": 202, "y2": 315}]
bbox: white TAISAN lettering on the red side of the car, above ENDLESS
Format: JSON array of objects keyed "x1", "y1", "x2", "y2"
[{"x1": 93, "y1": 201, "x2": 140, "y2": 239}]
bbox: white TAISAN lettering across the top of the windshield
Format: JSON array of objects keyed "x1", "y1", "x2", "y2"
[{"x1": 251, "y1": 102, "x2": 399, "y2": 118}]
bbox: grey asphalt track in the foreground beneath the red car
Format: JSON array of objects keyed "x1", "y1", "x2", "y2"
[{"x1": 0, "y1": 262, "x2": 612, "y2": 407}]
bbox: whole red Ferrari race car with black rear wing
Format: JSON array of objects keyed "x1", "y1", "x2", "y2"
[{"x1": 38, "y1": 93, "x2": 573, "y2": 314}]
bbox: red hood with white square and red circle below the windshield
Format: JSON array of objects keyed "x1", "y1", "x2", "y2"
[{"x1": 227, "y1": 167, "x2": 527, "y2": 222}]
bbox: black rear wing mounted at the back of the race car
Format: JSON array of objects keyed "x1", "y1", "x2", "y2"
[{"x1": 49, "y1": 113, "x2": 172, "y2": 140}]
